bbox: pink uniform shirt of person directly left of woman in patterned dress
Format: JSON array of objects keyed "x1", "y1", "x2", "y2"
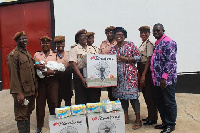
[{"x1": 100, "y1": 39, "x2": 117, "y2": 54}]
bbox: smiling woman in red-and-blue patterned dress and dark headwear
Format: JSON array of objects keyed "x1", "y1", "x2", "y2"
[{"x1": 110, "y1": 27, "x2": 142, "y2": 130}]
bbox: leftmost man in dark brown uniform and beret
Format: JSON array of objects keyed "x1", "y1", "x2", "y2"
[{"x1": 7, "y1": 31, "x2": 36, "y2": 133}]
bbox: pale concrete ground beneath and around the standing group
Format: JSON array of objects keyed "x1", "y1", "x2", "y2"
[{"x1": 0, "y1": 90, "x2": 200, "y2": 133}]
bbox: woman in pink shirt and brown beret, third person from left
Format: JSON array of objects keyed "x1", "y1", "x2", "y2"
[{"x1": 54, "y1": 36, "x2": 73, "y2": 108}]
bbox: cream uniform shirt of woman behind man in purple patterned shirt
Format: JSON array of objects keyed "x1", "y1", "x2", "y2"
[{"x1": 139, "y1": 39, "x2": 154, "y2": 63}]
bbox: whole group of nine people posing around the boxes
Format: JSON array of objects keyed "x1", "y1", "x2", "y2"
[{"x1": 7, "y1": 23, "x2": 177, "y2": 133}]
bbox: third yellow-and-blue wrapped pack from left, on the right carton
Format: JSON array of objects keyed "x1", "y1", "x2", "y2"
[{"x1": 86, "y1": 103, "x2": 102, "y2": 113}]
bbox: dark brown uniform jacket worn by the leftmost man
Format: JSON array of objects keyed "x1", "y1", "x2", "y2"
[{"x1": 7, "y1": 47, "x2": 37, "y2": 96}]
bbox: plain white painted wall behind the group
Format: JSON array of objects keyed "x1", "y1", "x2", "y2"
[{"x1": 0, "y1": 0, "x2": 196, "y2": 72}]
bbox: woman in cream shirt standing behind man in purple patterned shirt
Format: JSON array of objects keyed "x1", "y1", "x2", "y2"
[{"x1": 138, "y1": 26, "x2": 158, "y2": 125}]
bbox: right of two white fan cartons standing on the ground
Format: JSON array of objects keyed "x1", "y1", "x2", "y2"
[{"x1": 87, "y1": 111, "x2": 125, "y2": 133}]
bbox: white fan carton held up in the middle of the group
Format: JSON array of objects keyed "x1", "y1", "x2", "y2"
[{"x1": 83, "y1": 55, "x2": 117, "y2": 88}]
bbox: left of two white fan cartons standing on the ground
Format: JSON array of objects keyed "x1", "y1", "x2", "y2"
[{"x1": 49, "y1": 115, "x2": 87, "y2": 133}]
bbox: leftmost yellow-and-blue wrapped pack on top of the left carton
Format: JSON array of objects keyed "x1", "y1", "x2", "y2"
[{"x1": 55, "y1": 106, "x2": 71, "y2": 119}]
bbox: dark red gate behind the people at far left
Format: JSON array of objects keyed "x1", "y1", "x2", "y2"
[{"x1": 0, "y1": 1, "x2": 52, "y2": 89}]
